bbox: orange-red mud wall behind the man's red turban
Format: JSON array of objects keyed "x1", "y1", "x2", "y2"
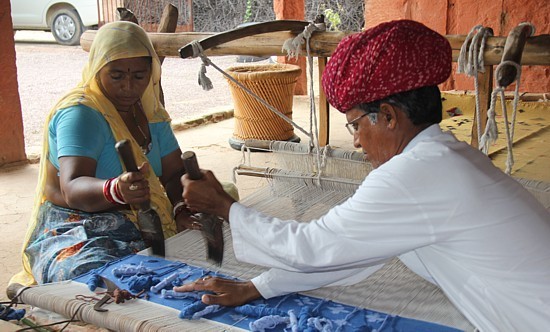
[{"x1": 365, "y1": 0, "x2": 550, "y2": 92}]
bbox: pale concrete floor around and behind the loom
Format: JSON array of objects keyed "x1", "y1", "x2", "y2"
[{"x1": 0, "y1": 96, "x2": 352, "y2": 301}]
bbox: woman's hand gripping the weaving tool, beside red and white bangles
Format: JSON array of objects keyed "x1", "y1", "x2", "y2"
[{"x1": 117, "y1": 163, "x2": 150, "y2": 204}]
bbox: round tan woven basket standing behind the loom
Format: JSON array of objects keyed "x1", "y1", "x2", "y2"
[{"x1": 226, "y1": 63, "x2": 301, "y2": 141}]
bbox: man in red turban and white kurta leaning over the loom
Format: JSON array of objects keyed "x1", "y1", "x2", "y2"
[{"x1": 178, "y1": 20, "x2": 550, "y2": 331}]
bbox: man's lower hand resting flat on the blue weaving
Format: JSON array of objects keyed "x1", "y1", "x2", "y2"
[{"x1": 174, "y1": 276, "x2": 261, "y2": 307}]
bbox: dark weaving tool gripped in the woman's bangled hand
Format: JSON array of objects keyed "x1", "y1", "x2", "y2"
[{"x1": 115, "y1": 140, "x2": 165, "y2": 257}]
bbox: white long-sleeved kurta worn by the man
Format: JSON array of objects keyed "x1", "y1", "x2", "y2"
[{"x1": 229, "y1": 125, "x2": 550, "y2": 331}]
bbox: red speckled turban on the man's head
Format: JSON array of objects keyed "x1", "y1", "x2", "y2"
[{"x1": 322, "y1": 20, "x2": 452, "y2": 113}]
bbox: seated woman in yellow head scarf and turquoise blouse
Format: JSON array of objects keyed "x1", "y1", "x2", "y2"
[{"x1": 10, "y1": 22, "x2": 198, "y2": 285}]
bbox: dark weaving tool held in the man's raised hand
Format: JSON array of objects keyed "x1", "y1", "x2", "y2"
[{"x1": 181, "y1": 151, "x2": 224, "y2": 265}]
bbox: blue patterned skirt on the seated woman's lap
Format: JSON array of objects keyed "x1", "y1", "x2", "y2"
[{"x1": 25, "y1": 202, "x2": 145, "y2": 284}]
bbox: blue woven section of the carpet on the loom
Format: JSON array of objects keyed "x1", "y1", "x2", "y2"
[{"x1": 75, "y1": 255, "x2": 460, "y2": 332}]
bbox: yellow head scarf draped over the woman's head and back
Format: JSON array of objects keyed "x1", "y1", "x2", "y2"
[{"x1": 10, "y1": 21, "x2": 176, "y2": 285}]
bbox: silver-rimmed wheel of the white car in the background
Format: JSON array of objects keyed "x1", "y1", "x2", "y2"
[{"x1": 51, "y1": 9, "x2": 84, "y2": 45}]
